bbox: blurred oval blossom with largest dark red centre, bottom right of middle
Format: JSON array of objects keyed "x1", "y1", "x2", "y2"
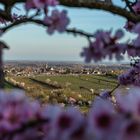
[{"x1": 88, "y1": 98, "x2": 114, "y2": 140}]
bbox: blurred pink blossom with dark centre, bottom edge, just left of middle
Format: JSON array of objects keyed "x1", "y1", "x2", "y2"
[{"x1": 44, "y1": 108, "x2": 84, "y2": 140}]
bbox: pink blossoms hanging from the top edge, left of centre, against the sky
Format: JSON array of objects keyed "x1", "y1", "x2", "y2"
[{"x1": 25, "y1": 0, "x2": 70, "y2": 34}]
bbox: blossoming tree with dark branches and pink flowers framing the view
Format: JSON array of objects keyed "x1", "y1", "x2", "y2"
[{"x1": 0, "y1": 0, "x2": 140, "y2": 140}]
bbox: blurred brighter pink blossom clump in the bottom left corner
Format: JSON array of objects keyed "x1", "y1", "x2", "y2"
[{"x1": 0, "y1": 91, "x2": 40, "y2": 133}]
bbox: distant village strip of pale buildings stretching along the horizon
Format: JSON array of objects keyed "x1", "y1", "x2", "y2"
[{"x1": 4, "y1": 62, "x2": 130, "y2": 77}]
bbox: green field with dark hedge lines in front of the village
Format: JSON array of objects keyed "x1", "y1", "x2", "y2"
[{"x1": 6, "y1": 75, "x2": 117, "y2": 106}]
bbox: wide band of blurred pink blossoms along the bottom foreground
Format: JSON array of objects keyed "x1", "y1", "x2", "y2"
[{"x1": 0, "y1": 87, "x2": 140, "y2": 140}]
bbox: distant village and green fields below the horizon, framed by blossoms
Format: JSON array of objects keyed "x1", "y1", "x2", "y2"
[{"x1": 1, "y1": 62, "x2": 129, "y2": 111}]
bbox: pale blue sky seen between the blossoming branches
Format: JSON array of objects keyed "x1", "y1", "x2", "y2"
[{"x1": 2, "y1": 2, "x2": 129, "y2": 61}]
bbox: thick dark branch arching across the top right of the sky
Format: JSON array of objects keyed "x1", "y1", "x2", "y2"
[{"x1": 59, "y1": 0, "x2": 140, "y2": 23}]
